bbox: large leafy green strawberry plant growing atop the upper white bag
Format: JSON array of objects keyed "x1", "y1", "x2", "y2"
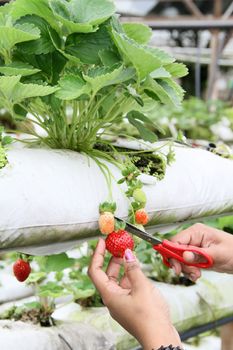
[{"x1": 0, "y1": 0, "x2": 187, "y2": 159}]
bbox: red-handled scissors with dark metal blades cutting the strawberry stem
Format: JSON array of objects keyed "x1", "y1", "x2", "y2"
[{"x1": 115, "y1": 217, "x2": 214, "y2": 269}]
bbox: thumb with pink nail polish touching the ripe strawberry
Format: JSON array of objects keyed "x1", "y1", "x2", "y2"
[{"x1": 124, "y1": 249, "x2": 147, "y2": 291}]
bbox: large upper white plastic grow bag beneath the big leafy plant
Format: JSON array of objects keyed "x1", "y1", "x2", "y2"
[{"x1": 0, "y1": 147, "x2": 233, "y2": 254}]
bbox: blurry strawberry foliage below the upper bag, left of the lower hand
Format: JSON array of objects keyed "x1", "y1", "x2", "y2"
[{"x1": 0, "y1": 240, "x2": 105, "y2": 327}]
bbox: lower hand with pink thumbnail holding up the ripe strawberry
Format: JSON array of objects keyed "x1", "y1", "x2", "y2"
[{"x1": 88, "y1": 239, "x2": 181, "y2": 350}]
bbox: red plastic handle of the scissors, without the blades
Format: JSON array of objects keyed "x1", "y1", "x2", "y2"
[{"x1": 153, "y1": 239, "x2": 214, "y2": 269}]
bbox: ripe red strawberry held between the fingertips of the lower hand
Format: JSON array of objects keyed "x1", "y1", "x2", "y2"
[{"x1": 105, "y1": 230, "x2": 134, "y2": 258}]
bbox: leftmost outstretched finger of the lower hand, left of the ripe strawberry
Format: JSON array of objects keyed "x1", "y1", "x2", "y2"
[{"x1": 88, "y1": 238, "x2": 109, "y2": 295}]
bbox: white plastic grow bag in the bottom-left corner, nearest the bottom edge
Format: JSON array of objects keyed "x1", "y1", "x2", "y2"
[{"x1": 0, "y1": 320, "x2": 115, "y2": 350}]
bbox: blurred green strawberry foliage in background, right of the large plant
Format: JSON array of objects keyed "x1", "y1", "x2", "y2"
[{"x1": 111, "y1": 97, "x2": 233, "y2": 142}]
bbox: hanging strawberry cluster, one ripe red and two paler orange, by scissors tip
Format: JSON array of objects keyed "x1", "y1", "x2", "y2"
[{"x1": 99, "y1": 202, "x2": 148, "y2": 258}]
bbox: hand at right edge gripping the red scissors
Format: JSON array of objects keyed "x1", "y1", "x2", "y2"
[{"x1": 170, "y1": 224, "x2": 233, "y2": 281}]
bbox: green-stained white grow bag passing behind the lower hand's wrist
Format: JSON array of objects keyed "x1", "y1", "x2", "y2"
[{"x1": 53, "y1": 271, "x2": 233, "y2": 350}]
